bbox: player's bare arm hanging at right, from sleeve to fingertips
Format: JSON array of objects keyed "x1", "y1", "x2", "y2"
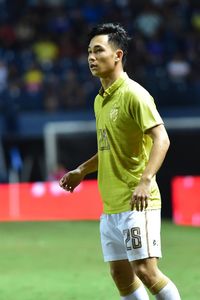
[{"x1": 131, "y1": 125, "x2": 170, "y2": 210}]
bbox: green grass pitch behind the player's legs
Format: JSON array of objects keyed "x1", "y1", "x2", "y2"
[{"x1": 0, "y1": 222, "x2": 200, "y2": 300}]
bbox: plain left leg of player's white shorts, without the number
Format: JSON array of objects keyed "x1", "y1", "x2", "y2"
[{"x1": 100, "y1": 214, "x2": 127, "y2": 262}]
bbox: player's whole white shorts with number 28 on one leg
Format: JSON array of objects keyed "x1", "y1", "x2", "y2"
[{"x1": 100, "y1": 209, "x2": 162, "y2": 262}]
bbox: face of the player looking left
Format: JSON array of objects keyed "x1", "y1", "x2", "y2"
[{"x1": 88, "y1": 35, "x2": 119, "y2": 78}]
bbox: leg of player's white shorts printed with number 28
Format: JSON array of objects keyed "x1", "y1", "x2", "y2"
[{"x1": 120, "y1": 209, "x2": 161, "y2": 261}]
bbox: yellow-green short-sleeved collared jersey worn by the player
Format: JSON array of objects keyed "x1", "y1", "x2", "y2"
[{"x1": 94, "y1": 72, "x2": 163, "y2": 214}]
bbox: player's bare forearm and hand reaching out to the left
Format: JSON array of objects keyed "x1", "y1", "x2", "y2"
[{"x1": 59, "y1": 153, "x2": 98, "y2": 192}]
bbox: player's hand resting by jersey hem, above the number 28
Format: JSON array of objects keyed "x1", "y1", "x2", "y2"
[{"x1": 130, "y1": 181, "x2": 150, "y2": 211}]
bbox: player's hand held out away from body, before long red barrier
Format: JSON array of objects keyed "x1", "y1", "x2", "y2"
[{"x1": 59, "y1": 168, "x2": 84, "y2": 193}]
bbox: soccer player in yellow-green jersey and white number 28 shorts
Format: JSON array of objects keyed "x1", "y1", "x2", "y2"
[{"x1": 60, "y1": 23, "x2": 180, "y2": 300}]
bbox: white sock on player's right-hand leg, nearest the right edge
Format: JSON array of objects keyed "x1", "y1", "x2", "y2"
[{"x1": 155, "y1": 281, "x2": 181, "y2": 300}]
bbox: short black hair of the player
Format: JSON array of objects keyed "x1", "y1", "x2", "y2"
[{"x1": 88, "y1": 23, "x2": 130, "y2": 65}]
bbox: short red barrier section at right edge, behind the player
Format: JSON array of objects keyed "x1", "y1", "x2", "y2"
[{"x1": 172, "y1": 176, "x2": 200, "y2": 226}]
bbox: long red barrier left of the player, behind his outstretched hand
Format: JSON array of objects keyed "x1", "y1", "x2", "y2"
[{"x1": 0, "y1": 180, "x2": 102, "y2": 221}]
